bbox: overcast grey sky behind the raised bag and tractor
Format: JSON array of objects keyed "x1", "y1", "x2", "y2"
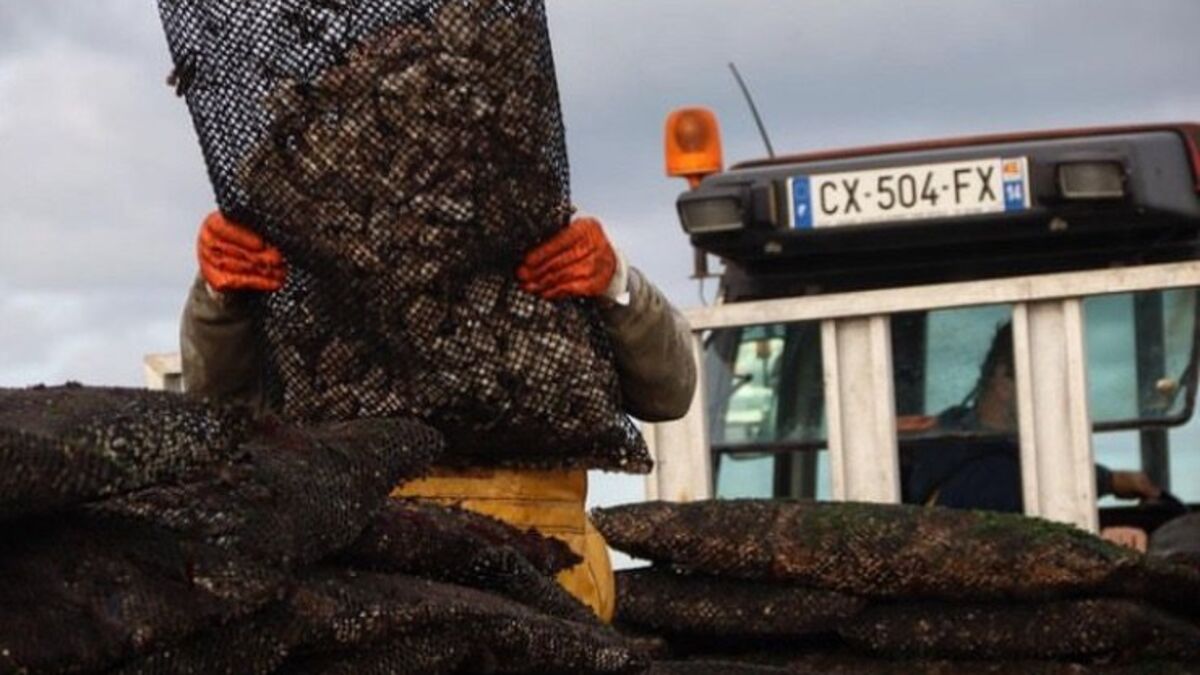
[{"x1": 0, "y1": 0, "x2": 1200, "y2": 504}]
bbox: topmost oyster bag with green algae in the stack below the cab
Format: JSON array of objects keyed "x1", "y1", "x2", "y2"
[{"x1": 593, "y1": 500, "x2": 1200, "y2": 611}]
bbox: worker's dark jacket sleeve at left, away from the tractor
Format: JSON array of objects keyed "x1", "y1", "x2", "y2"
[{"x1": 179, "y1": 270, "x2": 263, "y2": 410}]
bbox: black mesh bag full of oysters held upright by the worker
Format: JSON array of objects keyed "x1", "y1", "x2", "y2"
[{"x1": 158, "y1": 0, "x2": 649, "y2": 471}]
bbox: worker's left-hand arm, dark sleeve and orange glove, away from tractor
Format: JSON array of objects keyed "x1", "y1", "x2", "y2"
[{"x1": 180, "y1": 213, "x2": 287, "y2": 410}]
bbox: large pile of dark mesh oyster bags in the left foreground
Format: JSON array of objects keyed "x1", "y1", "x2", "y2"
[{"x1": 0, "y1": 386, "x2": 646, "y2": 674}]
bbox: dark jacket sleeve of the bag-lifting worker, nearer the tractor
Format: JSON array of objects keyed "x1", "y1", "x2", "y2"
[{"x1": 604, "y1": 268, "x2": 696, "y2": 422}]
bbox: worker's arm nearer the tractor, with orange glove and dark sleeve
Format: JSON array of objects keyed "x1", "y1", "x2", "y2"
[{"x1": 517, "y1": 217, "x2": 696, "y2": 422}]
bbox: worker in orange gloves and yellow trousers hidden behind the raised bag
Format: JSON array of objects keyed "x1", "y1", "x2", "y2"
[{"x1": 180, "y1": 213, "x2": 696, "y2": 621}]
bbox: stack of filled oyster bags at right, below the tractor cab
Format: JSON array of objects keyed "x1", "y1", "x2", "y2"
[{"x1": 594, "y1": 501, "x2": 1200, "y2": 673}]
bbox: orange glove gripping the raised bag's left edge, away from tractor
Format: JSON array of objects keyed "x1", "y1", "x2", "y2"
[{"x1": 197, "y1": 211, "x2": 288, "y2": 293}]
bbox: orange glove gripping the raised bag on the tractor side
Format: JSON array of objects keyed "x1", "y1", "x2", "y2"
[{"x1": 517, "y1": 217, "x2": 617, "y2": 300}]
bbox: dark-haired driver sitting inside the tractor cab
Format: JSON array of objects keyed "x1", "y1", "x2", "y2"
[{"x1": 905, "y1": 323, "x2": 1163, "y2": 513}]
